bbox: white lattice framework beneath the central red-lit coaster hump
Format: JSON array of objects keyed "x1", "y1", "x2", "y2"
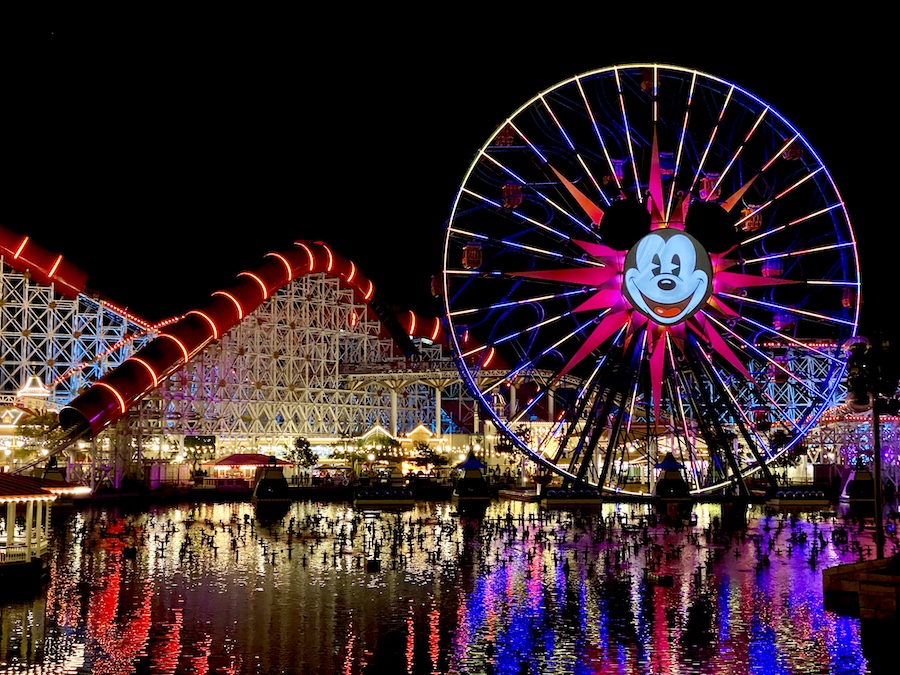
[{"x1": 134, "y1": 274, "x2": 435, "y2": 448}]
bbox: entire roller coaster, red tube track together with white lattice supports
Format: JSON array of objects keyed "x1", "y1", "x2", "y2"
[{"x1": 0, "y1": 228, "x2": 900, "y2": 489}]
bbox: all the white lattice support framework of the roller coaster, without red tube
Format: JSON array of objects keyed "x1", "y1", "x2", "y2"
[{"x1": 0, "y1": 258, "x2": 900, "y2": 488}]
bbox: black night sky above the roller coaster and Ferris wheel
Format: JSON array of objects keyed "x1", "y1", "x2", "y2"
[{"x1": 0, "y1": 15, "x2": 900, "y2": 346}]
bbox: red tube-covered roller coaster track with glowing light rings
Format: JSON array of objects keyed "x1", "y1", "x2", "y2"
[{"x1": 0, "y1": 228, "x2": 443, "y2": 480}]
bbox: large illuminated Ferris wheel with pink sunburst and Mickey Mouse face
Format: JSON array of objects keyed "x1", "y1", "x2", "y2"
[{"x1": 441, "y1": 64, "x2": 859, "y2": 494}]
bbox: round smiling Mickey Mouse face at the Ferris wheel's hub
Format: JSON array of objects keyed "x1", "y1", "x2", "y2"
[{"x1": 622, "y1": 228, "x2": 712, "y2": 326}]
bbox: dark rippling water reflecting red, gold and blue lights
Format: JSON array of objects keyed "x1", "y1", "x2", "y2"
[{"x1": 0, "y1": 500, "x2": 898, "y2": 675}]
